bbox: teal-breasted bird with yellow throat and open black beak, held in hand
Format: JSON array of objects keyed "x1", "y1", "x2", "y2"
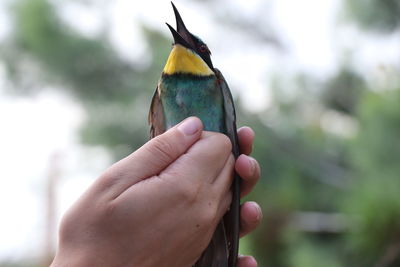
[{"x1": 148, "y1": 2, "x2": 241, "y2": 267}]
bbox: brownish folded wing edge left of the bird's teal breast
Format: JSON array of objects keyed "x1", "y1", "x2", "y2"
[{"x1": 148, "y1": 86, "x2": 166, "y2": 138}]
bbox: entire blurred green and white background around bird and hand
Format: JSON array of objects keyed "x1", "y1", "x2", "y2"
[{"x1": 0, "y1": 0, "x2": 400, "y2": 267}]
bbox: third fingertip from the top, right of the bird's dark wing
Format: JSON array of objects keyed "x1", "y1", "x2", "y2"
[{"x1": 239, "y1": 201, "x2": 262, "y2": 237}]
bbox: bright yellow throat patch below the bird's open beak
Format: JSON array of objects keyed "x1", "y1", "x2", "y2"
[{"x1": 163, "y1": 44, "x2": 214, "y2": 76}]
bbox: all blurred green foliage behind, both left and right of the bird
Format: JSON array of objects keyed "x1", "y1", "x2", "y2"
[{"x1": 0, "y1": 0, "x2": 400, "y2": 267}]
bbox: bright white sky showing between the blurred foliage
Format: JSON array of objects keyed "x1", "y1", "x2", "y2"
[{"x1": 0, "y1": 0, "x2": 400, "y2": 261}]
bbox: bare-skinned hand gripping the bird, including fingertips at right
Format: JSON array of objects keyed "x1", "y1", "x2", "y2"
[{"x1": 51, "y1": 117, "x2": 262, "y2": 267}]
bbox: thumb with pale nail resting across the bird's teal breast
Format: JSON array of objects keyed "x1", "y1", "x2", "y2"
[{"x1": 101, "y1": 117, "x2": 203, "y2": 195}]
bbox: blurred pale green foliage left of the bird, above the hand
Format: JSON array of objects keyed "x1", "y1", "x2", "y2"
[{"x1": 2, "y1": 0, "x2": 170, "y2": 158}]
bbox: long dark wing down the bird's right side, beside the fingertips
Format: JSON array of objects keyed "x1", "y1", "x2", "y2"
[{"x1": 215, "y1": 69, "x2": 241, "y2": 266}]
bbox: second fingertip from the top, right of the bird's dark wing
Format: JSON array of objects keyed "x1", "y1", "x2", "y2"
[{"x1": 235, "y1": 154, "x2": 261, "y2": 197}]
